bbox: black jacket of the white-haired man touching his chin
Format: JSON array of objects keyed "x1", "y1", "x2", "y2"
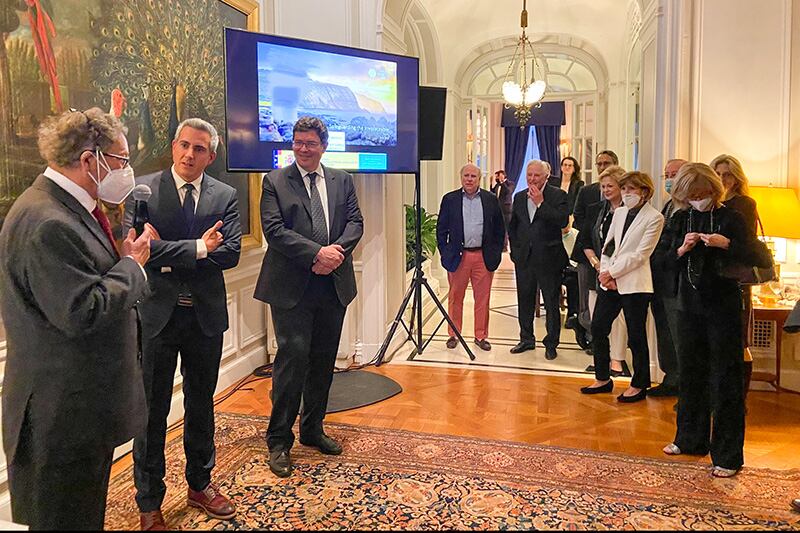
[{"x1": 508, "y1": 185, "x2": 569, "y2": 271}]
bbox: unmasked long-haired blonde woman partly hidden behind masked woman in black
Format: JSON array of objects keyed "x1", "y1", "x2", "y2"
[{"x1": 711, "y1": 154, "x2": 758, "y2": 408}]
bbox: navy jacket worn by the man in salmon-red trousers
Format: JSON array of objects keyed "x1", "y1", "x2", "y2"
[{"x1": 436, "y1": 188, "x2": 508, "y2": 272}]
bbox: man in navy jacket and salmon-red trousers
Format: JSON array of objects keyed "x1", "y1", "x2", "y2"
[{"x1": 436, "y1": 164, "x2": 506, "y2": 351}]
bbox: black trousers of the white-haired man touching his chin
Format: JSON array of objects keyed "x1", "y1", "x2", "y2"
[{"x1": 514, "y1": 261, "x2": 561, "y2": 348}]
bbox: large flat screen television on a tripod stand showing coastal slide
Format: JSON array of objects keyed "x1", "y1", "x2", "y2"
[{"x1": 225, "y1": 28, "x2": 419, "y2": 173}]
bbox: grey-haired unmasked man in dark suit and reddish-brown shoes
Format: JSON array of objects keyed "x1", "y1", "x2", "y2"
[{"x1": 125, "y1": 118, "x2": 242, "y2": 530}]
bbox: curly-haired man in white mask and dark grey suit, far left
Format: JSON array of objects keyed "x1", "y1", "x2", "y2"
[{"x1": 0, "y1": 108, "x2": 153, "y2": 530}]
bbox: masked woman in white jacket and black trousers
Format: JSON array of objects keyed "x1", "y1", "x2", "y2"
[{"x1": 581, "y1": 172, "x2": 664, "y2": 403}]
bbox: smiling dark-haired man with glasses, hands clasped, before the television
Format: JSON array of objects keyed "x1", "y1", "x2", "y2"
[{"x1": 254, "y1": 117, "x2": 364, "y2": 477}]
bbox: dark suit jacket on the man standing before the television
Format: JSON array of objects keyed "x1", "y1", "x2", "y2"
[{"x1": 254, "y1": 164, "x2": 364, "y2": 309}]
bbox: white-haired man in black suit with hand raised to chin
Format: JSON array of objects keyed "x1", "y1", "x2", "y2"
[{"x1": 508, "y1": 159, "x2": 569, "y2": 360}]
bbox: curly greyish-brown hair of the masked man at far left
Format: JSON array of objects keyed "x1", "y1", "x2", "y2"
[{"x1": 38, "y1": 107, "x2": 128, "y2": 167}]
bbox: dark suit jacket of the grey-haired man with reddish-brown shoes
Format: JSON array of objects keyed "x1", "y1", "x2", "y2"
[{"x1": 123, "y1": 168, "x2": 242, "y2": 338}]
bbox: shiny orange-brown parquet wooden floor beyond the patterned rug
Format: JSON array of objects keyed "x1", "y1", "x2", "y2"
[{"x1": 114, "y1": 363, "x2": 800, "y2": 471}]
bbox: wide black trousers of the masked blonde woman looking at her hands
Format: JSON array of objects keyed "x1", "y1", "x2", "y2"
[{"x1": 675, "y1": 304, "x2": 745, "y2": 469}]
